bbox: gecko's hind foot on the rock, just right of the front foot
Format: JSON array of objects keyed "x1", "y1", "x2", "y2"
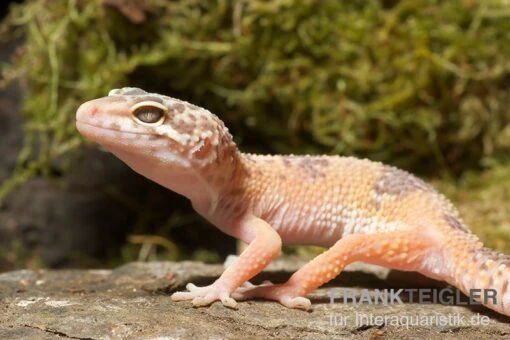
[{"x1": 232, "y1": 281, "x2": 312, "y2": 310}]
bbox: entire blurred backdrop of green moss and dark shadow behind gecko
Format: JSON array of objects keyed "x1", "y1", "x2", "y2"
[{"x1": 0, "y1": 0, "x2": 510, "y2": 271}]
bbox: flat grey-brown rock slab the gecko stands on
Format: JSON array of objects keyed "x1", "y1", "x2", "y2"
[{"x1": 0, "y1": 260, "x2": 510, "y2": 339}]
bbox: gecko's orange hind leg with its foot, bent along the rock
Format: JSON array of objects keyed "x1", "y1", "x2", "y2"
[{"x1": 232, "y1": 231, "x2": 433, "y2": 310}]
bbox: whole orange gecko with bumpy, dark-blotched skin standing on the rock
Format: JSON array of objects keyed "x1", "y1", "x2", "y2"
[{"x1": 77, "y1": 88, "x2": 510, "y2": 315}]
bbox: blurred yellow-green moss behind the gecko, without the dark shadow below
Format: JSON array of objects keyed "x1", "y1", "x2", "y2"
[{"x1": 0, "y1": 0, "x2": 510, "y2": 266}]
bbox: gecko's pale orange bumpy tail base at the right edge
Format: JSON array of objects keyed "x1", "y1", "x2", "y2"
[{"x1": 449, "y1": 235, "x2": 510, "y2": 316}]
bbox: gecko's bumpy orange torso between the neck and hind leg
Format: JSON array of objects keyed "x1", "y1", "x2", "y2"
[{"x1": 223, "y1": 155, "x2": 442, "y2": 246}]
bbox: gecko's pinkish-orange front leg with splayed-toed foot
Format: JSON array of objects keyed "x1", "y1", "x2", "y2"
[{"x1": 172, "y1": 216, "x2": 282, "y2": 308}]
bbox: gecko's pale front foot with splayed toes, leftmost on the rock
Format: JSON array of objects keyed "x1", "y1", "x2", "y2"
[{"x1": 171, "y1": 283, "x2": 237, "y2": 308}]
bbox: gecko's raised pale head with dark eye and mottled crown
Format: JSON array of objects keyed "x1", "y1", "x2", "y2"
[{"x1": 76, "y1": 87, "x2": 235, "y2": 172}]
